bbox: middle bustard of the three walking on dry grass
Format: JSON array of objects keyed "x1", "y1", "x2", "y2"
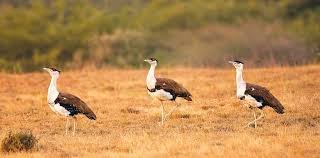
[{"x1": 144, "y1": 58, "x2": 192, "y2": 125}]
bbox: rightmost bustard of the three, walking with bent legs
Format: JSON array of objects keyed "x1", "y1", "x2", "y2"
[{"x1": 229, "y1": 60, "x2": 284, "y2": 128}]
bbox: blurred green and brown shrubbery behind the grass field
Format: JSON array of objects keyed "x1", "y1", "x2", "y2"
[{"x1": 0, "y1": 0, "x2": 320, "y2": 72}]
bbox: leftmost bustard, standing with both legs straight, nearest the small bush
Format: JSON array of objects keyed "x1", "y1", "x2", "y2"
[{"x1": 43, "y1": 67, "x2": 97, "y2": 135}]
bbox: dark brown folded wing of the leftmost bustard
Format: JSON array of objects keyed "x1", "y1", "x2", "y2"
[{"x1": 55, "y1": 93, "x2": 96, "y2": 120}]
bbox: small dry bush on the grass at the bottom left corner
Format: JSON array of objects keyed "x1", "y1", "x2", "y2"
[{"x1": 1, "y1": 132, "x2": 38, "y2": 152}]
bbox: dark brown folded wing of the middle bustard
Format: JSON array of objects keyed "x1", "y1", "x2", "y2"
[{"x1": 155, "y1": 78, "x2": 192, "y2": 101}]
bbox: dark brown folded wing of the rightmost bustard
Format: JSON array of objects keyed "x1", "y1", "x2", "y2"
[{"x1": 244, "y1": 83, "x2": 284, "y2": 114}]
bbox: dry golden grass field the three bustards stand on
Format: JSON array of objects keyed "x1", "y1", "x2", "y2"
[{"x1": 0, "y1": 65, "x2": 320, "y2": 158}]
